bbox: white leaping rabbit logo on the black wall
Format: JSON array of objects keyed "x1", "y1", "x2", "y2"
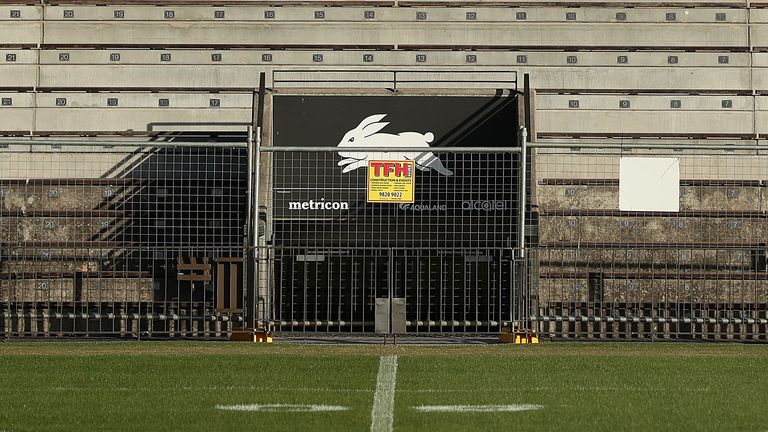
[{"x1": 338, "y1": 114, "x2": 453, "y2": 176}]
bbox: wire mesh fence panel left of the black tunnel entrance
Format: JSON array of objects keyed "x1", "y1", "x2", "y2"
[{"x1": 0, "y1": 139, "x2": 248, "y2": 337}]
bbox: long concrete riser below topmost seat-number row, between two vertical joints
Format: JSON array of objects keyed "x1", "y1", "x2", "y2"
[{"x1": 44, "y1": 21, "x2": 744, "y2": 47}]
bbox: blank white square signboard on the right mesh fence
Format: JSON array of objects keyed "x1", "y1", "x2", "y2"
[{"x1": 619, "y1": 157, "x2": 680, "y2": 212}]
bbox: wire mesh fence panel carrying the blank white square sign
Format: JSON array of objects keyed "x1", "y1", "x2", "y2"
[{"x1": 531, "y1": 143, "x2": 768, "y2": 340}]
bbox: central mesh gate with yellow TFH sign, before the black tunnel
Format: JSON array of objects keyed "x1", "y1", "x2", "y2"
[{"x1": 258, "y1": 147, "x2": 525, "y2": 334}]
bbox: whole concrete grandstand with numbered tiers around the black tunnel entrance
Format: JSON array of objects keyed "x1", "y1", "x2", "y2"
[{"x1": 0, "y1": 0, "x2": 768, "y2": 340}]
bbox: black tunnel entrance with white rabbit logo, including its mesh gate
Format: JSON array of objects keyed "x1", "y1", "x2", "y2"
[{"x1": 256, "y1": 93, "x2": 527, "y2": 334}]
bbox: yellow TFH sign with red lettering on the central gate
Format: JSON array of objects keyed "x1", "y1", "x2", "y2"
[{"x1": 368, "y1": 161, "x2": 416, "y2": 203}]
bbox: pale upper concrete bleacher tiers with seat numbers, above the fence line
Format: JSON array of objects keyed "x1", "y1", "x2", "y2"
[{"x1": 0, "y1": 1, "x2": 768, "y2": 139}]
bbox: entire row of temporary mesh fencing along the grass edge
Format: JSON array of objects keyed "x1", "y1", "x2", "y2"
[{"x1": 0, "y1": 140, "x2": 768, "y2": 340}]
